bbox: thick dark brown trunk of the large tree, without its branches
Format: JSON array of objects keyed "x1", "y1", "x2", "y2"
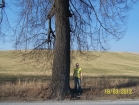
[{"x1": 50, "y1": 0, "x2": 70, "y2": 99}]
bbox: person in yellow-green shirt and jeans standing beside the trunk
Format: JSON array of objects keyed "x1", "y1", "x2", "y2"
[{"x1": 73, "y1": 63, "x2": 83, "y2": 94}]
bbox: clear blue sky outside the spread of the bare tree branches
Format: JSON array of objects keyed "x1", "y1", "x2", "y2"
[{"x1": 0, "y1": 0, "x2": 139, "y2": 53}]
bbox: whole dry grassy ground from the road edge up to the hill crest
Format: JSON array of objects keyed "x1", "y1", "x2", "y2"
[{"x1": 0, "y1": 51, "x2": 139, "y2": 101}]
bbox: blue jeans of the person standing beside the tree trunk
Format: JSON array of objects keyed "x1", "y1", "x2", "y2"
[{"x1": 74, "y1": 77, "x2": 82, "y2": 93}]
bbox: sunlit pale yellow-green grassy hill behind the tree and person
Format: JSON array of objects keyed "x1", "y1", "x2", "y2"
[{"x1": 0, "y1": 51, "x2": 139, "y2": 80}]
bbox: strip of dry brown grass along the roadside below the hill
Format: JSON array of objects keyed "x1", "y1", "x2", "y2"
[{"x1": 0, "y1": 77, "x2": 139, "y2": 101}]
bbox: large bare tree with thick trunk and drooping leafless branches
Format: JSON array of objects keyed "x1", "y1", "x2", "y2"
[{"x1": 7, "y1": 0, "x2": 136, "y2": 99}]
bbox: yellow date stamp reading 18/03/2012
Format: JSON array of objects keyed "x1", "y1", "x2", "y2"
[{"x1": 104, "y1": 88, "x2": 133, "y2": 95}]
